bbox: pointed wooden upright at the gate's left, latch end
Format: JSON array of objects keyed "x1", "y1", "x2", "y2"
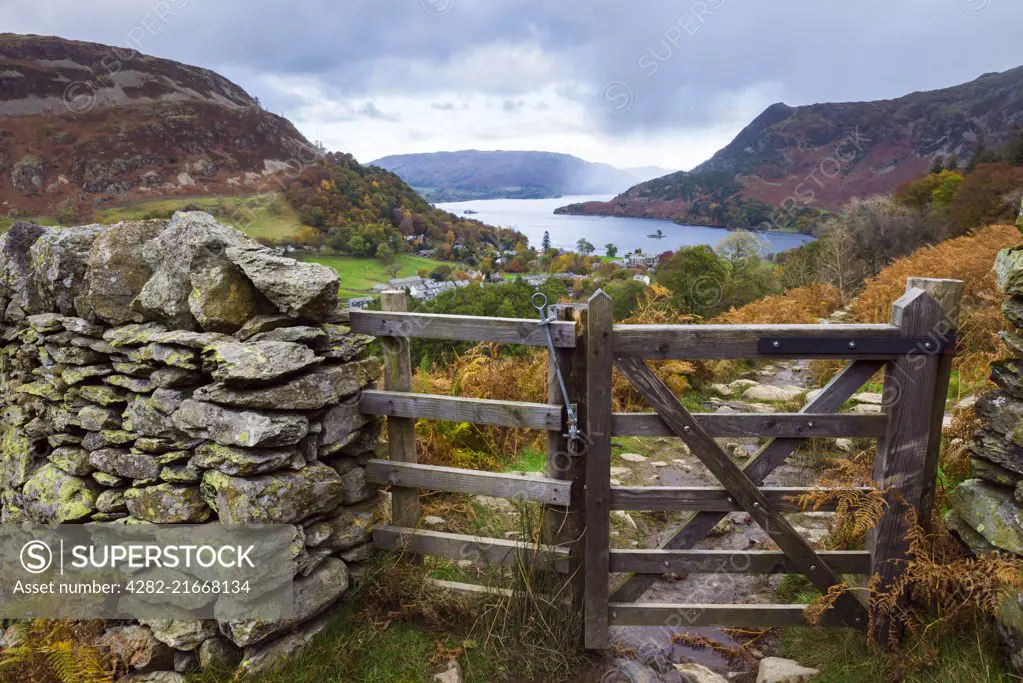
[{"x1": 583, "y1": 289, "x2": 614, "y2": 649}]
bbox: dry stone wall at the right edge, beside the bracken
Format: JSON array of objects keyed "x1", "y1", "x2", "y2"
[{"x1": 945, "y1": 241, "x2": 1023, "y2": 671}]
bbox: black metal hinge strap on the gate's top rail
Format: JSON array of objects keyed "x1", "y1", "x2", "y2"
[{"x1": 757, "y1": 331, "x2": 955, "y2": 358}]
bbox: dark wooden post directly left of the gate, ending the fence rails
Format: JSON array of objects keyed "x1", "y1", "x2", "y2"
[{"x1": 543, "y1": 305, "x2": 587, "y2": 613}]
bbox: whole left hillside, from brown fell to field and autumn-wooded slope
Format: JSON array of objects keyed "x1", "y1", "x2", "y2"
[{"x1": 0, "y1": 34, "x2": 522, "y2": 258}]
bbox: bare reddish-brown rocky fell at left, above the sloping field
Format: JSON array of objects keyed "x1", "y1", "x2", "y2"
[{"x1": 0, "y1": 34, "x2": 313, "y2": 215}]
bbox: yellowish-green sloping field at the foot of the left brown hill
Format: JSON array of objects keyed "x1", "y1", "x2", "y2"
[{"x1": 96, "y1": 192, "x2": 302, "y2": 239}]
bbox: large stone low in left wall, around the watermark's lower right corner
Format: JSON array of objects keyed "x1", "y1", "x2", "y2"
[{"x1": 220, "y1": 557, "x2": 348, "y2": 647}]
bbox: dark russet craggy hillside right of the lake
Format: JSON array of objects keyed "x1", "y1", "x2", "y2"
[{"x1": 559, "y1": 66, "x2": 1023, "y2": 229}]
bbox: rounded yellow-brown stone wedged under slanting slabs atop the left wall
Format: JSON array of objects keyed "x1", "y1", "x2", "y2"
[{"x1": 188, "y1": 263, "x2": 275, "y2": 334}]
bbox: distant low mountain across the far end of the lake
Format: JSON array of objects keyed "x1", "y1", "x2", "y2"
[{"x1": 371, "y1": 149, "x2": 663, "y2": 201}]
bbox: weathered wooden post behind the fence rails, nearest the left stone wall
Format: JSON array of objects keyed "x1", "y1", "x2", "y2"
[{"x1": 381, "y1": 289, "x2": 419, "y2": 529}]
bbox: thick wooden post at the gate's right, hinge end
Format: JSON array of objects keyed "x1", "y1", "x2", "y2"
[{"x1": 869, "y1": 286, "x2": 947, "y2": 643}]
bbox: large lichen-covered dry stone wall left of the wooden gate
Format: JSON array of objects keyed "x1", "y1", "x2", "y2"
[{"x1": 0, "y1": 213, "x2": 380, "y2": 680}]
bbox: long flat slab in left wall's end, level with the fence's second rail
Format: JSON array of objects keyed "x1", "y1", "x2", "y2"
[{"x1": 194, "y1": 358, "x2": 381, "y2": 410}]
